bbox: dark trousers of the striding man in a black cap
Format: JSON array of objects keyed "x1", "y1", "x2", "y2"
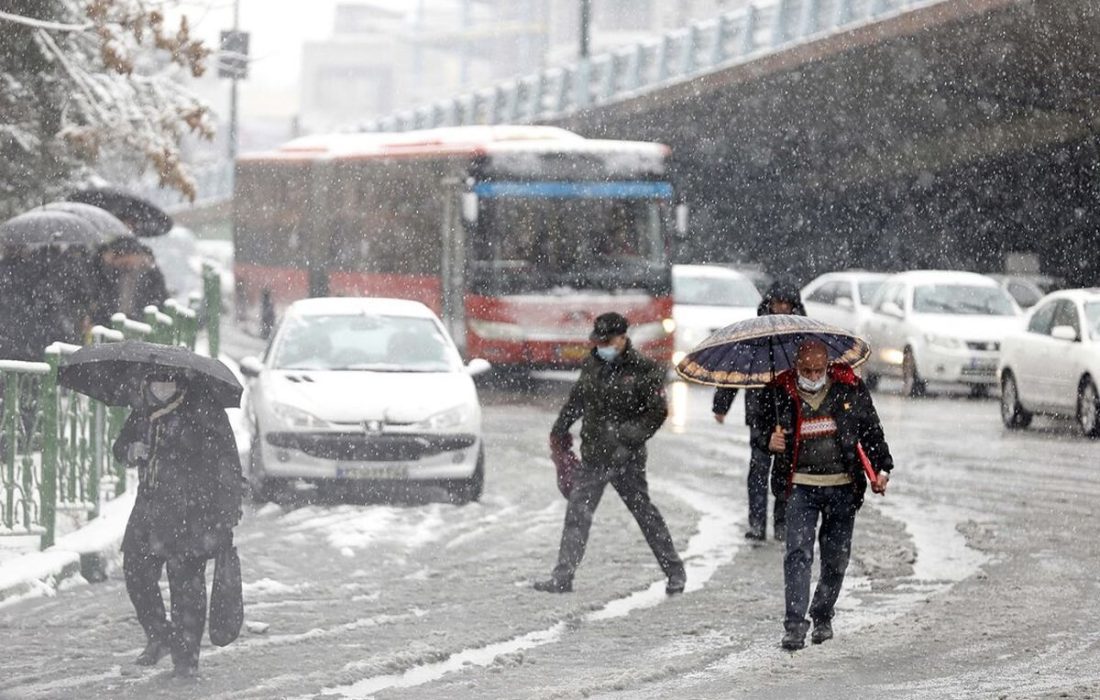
[{"x1": 553, "y1": 451, "x2": 684, "y2": 581}]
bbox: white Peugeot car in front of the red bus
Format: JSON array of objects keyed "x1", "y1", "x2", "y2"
[{"x1": 241, "y1": 298, "x2": 490, "y2": 502}]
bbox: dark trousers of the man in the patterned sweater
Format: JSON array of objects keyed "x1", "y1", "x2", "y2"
[{"x1": 783, "y1": 484, "x2": 856, "y2": 633}]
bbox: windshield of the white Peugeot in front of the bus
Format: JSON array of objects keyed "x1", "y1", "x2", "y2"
[{"x1": 274, "y1": 314, "x2": 458, "y2": 372}]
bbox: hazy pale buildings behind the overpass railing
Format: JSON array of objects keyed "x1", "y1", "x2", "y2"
[{"x1": 299, "y1": 0, "x2": 748, "y2": 133}]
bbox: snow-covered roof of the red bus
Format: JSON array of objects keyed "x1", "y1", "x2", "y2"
[{"x1": 241, "y1": 125, "x2": 669, "y2": 161}]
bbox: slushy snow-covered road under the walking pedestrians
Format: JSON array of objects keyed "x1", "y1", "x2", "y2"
[{"x1": 0, "y1": 380, "x2": 1100, "y2": 700}]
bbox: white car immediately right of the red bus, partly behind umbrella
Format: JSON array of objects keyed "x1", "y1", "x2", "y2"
[{"x1": 672, "y1": 265, "x2": 761, "y2": 364}]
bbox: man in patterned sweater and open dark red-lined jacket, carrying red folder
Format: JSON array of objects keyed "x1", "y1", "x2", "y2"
[{"x1": 755, "y1": 340, "x2": 893, "y2": 650}]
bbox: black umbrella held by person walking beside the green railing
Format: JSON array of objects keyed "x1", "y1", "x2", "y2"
[{"x1": 57, "y1": 340, "x2": 243, "y2": 408}]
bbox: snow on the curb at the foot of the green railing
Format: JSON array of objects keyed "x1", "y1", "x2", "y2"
[{"x1": 0, "y1": 489, "x2": 136, "y2": 606}]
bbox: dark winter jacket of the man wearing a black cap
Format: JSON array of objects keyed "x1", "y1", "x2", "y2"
[{"x1": 550, "y1": 341, "x2": 669, "y2": 468}]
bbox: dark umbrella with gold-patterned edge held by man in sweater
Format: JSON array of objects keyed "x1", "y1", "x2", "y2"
[{"x1": 677, "y1": 314, "x2": 871, "y2": 389}]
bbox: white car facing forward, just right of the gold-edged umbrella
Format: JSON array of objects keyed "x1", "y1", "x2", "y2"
[{"x1": 859, "y1": 270, "x2": 1022, "y2": 396}]
